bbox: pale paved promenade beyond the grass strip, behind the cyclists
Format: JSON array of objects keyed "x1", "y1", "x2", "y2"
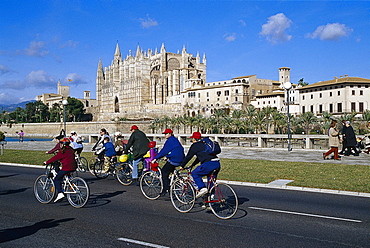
[{"x1": 4, "y1": 141, "x2": 370, "y2": 166}]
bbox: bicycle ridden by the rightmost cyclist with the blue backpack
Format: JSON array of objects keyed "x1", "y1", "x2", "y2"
[{"x1": 170, "y1": 167, "x2": 239, "y2": 219}]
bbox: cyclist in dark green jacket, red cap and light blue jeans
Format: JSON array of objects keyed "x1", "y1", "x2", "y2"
[{"x1": 124, "y1": 125, "x2": 149, "y2": 181}]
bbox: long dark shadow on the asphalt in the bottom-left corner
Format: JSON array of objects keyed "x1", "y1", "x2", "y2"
[{"x1": 0, "y1": 218, "x2": 74, "y2": 243}]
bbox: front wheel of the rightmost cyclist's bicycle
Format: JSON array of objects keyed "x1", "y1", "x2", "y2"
[{"x1": 170, "y1": 178, "x2": 195, "y2": 213}]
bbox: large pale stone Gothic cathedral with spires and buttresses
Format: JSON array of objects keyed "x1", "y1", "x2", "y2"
[{"x1": 95, "y1": 44, "x2": 206, "y2": 121}]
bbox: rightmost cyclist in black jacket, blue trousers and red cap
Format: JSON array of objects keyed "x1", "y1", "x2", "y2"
[{"x1": 180, "y1": 132, "x2": 221, "y2": 198}]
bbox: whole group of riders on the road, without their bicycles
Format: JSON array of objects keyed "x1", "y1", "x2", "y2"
[{"x1": 44, "y1": 125, "x2": 220, "y2": 202}]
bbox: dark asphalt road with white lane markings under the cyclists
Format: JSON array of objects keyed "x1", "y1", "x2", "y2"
[{"x1": 0, "y1": 165, "x2": 370, "y2": 247}]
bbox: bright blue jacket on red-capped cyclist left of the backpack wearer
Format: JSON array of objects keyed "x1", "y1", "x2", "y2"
[{"x1": 155, "y1": 135, "x2": 185, "y2": 166}]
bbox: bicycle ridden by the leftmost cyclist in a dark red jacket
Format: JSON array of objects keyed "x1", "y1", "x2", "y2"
[{"x1": 33, "y1": 166, "x2": 90, "y2": 208}]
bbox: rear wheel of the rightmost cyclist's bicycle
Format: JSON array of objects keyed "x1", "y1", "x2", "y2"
[{"x1": 207, "y1": 183, "x2": 239, "y2": 219}]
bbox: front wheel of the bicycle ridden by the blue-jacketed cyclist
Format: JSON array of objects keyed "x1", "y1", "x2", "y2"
[{"x1": 140, "y1": 171, "x2": 163, "y2": 200}]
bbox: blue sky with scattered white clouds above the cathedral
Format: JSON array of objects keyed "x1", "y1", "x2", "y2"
[{"x1": 0, "y1": 0, "x2": 370, "y2": 104}]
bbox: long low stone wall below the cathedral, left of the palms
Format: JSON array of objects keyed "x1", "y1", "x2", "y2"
[{"x1": 0, "y1": 121, "x2": 152, "y2": 137}]
